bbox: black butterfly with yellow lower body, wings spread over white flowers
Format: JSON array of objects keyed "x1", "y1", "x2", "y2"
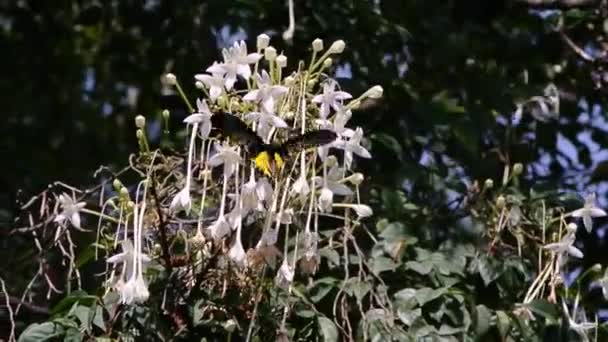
[{"x1": 211, "y1": 113, "x2": 338, "y2": 176}]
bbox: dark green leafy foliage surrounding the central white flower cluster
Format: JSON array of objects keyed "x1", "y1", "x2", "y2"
[{"x1": 0, "y1": 0, "x2": 608, "y2": 341}]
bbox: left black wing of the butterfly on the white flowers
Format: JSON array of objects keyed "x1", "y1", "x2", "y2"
[{"x1": 211, "y1": 113, "x2": 264, "y2": 150}]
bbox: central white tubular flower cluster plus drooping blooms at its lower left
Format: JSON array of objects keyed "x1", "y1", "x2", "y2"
[{"x1": 102, "y1": 34, "x2": 382, "y2": 304}]
